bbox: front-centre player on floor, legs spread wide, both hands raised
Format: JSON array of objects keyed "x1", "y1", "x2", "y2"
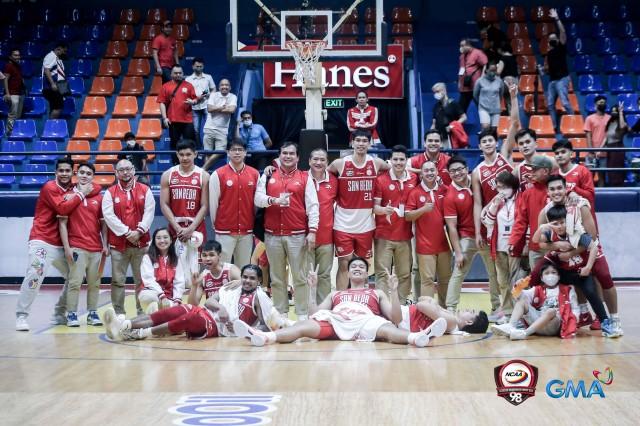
[{"x1": 233, "y1": 257, "x2": 447, "y2": 347}]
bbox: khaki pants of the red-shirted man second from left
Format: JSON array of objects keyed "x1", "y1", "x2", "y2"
[{"x1": 64, "y1": 248, "x2": 102, "y2": 313}]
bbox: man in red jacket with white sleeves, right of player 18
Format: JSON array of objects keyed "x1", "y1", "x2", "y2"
[{"x1": 209, "y1": 139, "x2": 260, "y2": 268}]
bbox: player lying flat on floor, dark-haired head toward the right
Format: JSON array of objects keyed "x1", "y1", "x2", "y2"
[{"x1": 398, "y1": 296, "x2": 489, "y2": 334}]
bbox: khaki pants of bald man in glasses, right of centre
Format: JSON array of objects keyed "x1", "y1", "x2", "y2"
[{"x1": 416, "y1": 251, "x2": 453, "y2": 308}]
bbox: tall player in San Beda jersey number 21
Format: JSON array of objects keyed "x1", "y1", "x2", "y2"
[{"x1": 327, "y1": 130, "x2": 390, "y2": 290}]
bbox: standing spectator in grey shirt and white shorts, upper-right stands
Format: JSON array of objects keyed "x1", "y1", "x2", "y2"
[{"x1": 473, "y1": 62, "x2": 504, "y2": 130}]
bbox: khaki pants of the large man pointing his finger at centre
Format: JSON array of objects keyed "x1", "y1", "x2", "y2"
[{"x1": 264, "y1": 233, "x2": 309, "y2": 315}]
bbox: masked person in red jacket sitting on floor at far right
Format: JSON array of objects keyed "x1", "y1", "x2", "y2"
[{"x1": 491, "y1": 261, "x2": 580, "y2": 340}]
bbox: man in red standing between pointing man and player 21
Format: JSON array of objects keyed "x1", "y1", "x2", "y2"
[{"x1": 309, "y1": 148, "x2": 338, "y2": 303}]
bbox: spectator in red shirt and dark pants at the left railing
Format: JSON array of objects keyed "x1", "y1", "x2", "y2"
[{"x1": 158, "y1": 65, "x2": 198, "y2": 164}]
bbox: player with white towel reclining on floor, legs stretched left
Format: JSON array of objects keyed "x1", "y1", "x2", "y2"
[{"x1": 104, "y1": 264, "x2": 279, "y2": 340}]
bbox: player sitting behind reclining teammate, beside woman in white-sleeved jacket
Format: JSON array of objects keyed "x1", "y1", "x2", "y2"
[{"x1": 189, "y1": 240, "x2": 240, "y2": 306}]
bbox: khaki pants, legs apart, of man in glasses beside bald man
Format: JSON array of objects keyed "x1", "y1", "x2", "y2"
[{"x1": 447, "y1": 238, "x2": 500, "y2": 311}]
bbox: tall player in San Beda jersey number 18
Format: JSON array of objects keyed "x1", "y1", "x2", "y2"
[{"x1": 160, "y1": 139, "x2": 209, "y2": 283}]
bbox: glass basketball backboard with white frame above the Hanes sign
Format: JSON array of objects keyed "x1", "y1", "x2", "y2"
[{"x1": 227, "y1": 0, "x2": 387, "y2": 62}]
